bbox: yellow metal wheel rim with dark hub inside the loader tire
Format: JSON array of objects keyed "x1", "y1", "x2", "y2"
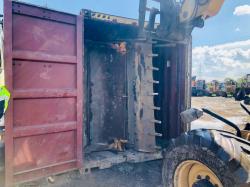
[{"x1": 174, "y1": 160, "x2": 223, "y2": 187}]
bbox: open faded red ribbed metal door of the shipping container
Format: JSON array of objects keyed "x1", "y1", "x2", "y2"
[{"x1": 4, "y1": 0, "x2": 83, "y2": 186}]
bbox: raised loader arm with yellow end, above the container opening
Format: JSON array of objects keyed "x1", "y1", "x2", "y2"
[{"x1": 138, "y1": 0, "x2": 224, "y2": 41}]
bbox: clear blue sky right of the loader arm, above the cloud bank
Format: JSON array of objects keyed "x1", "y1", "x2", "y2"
[{"x1": 193, "y1": 0, "x2": 250, "y2": 46}]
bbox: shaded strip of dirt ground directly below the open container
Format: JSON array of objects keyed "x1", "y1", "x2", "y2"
[{"x1": 22, "y1": 161, "x2": 162, "y2": 187}]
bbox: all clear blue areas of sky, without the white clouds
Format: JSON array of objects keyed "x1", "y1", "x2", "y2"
[{"x1": 0, "y1": 0, "x2": 250, "y2": 47}]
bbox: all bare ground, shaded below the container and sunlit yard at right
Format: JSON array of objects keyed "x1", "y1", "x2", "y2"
[{"x1": 17, "y1": 97, "x2": 249, "y2": 187}]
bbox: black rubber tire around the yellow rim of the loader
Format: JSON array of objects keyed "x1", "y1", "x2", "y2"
[{"x1": 162, "y1": 129, "x2": 248, "y2": 187}]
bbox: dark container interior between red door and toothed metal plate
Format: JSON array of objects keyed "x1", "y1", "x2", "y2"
[{"x1": 84, "y1": 19, "x2": 137, "y2": 150}]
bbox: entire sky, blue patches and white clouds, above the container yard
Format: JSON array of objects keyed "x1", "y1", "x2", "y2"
[{"x1": 0, "y1": 0, "x2": 250, "y2": 80}]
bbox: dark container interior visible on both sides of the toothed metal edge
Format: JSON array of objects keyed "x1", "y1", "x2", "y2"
[{"x1": 84, "y1": 16, "x2": 175, "y2": 152}]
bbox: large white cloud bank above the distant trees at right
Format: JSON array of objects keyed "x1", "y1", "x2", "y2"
[{"x1": 193, "y1": 40, "x2": 250, "y2": 81}]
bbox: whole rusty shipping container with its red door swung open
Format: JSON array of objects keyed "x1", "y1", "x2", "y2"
[{"x1": 0, "y1": 0, "x2": 191, "y2": 186}]
